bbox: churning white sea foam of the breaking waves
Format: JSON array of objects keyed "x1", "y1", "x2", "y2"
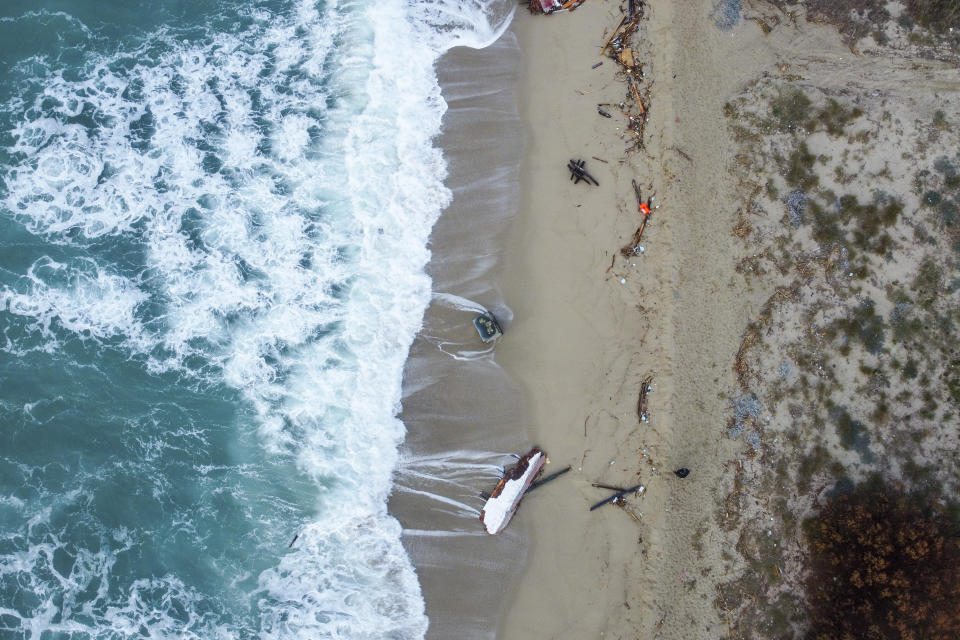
[{"x1": 0, "y1": 0, "x2": 515, "y2": 640}]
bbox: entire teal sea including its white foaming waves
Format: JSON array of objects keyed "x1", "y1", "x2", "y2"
[{"x1": 0, "y1": 0, "x2": 515, "y2": 640}]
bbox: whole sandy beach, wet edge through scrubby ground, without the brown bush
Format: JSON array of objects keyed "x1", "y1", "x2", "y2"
[{"x1": 391, "y1": 0, "x2": 960, "y2": 640}]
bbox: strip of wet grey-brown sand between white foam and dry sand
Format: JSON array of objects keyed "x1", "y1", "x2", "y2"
[{"x1": 389, "y1": 30, "x2": 530, "y2": 640}]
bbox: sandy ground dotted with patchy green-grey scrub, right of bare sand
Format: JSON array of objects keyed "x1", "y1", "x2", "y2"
[{"x1": 716, "y1": 55, "x2": 960, "y2": 640}]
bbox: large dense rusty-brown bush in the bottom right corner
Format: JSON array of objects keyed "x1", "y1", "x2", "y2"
[{"x1": 804, "y1": 478, "x2": 960, "y2": 640}]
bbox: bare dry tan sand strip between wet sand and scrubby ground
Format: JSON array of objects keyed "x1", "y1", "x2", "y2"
[{"x1": 498, "y1": 0, "x2": 757, "y2": 639}]
